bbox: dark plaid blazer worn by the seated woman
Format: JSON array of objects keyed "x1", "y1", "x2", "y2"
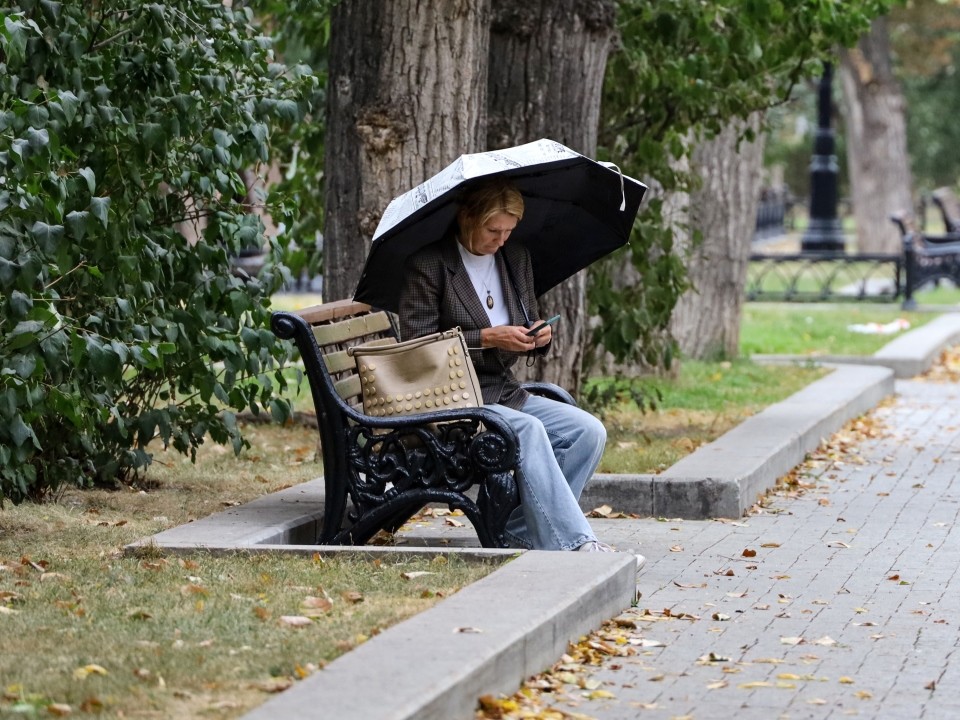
[{"x1": 399, "y1": 237, "x2": 546, "y2": 410}]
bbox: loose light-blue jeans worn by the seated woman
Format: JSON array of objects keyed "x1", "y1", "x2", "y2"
[{"x1": 484, "y1": 395, "x2": 607, "y2": 550}]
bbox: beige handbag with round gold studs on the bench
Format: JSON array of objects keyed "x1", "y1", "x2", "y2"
[{"x1": 347, "y1": 328, "x2": 483, "y2": 417}]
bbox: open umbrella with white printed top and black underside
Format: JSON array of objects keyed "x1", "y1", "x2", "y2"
[{"x1": 354, "y1": 139, "x2": 647, "y2": 312}]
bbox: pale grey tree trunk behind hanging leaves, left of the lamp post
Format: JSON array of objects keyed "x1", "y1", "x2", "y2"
[{"x1": 671, "y1": 115, "x2": 763, "y2": 360}]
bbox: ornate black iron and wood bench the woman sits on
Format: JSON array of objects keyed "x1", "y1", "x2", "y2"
[{"x1": 271, "y1": 300, "x2": 573, "y2": 547}]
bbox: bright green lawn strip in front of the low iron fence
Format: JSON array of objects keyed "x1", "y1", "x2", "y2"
[{"x1": 740, "y1": 303, "x2": 936, "y2": 357}]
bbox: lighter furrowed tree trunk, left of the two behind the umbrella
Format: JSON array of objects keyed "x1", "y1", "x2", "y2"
[{"x1": 323, "y1": 0, "x2": 490, "y2": 300}]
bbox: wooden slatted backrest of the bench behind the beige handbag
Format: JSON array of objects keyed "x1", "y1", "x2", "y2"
[{"x1": 295, "y1": 300, "x2": 397, "y2": 406}]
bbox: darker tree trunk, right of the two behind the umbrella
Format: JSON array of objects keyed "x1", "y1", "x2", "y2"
[{"x1": 487, "y1": 0, "x2": 616, "y2": 393}]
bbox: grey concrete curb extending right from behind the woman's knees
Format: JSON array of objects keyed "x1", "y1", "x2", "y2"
[{"x1": 580, "y1": 366, "x2": 894, "y2": 520}]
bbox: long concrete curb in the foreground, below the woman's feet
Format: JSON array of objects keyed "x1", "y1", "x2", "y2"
[{"x1": 244, "y1": 551, "x2": 636, "y2": 720}]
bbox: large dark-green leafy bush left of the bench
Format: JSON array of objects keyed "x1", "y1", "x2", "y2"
[{"x1": 0, "y1": 0, "x2": 313, "y2": 501}]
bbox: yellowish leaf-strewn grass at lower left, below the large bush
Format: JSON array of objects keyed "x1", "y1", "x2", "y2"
[{"x1": 0, "y1": 426, "x2": 502, "y2": 718}]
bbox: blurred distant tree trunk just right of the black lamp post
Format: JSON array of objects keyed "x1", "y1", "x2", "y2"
[{"x1": 840, "y1": 18, "x2": 912, "y2": 253}]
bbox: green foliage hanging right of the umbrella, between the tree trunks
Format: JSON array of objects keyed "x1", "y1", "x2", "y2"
[{"x1": 589, "y1": 0, "x2": 891, "y2": 364}]
